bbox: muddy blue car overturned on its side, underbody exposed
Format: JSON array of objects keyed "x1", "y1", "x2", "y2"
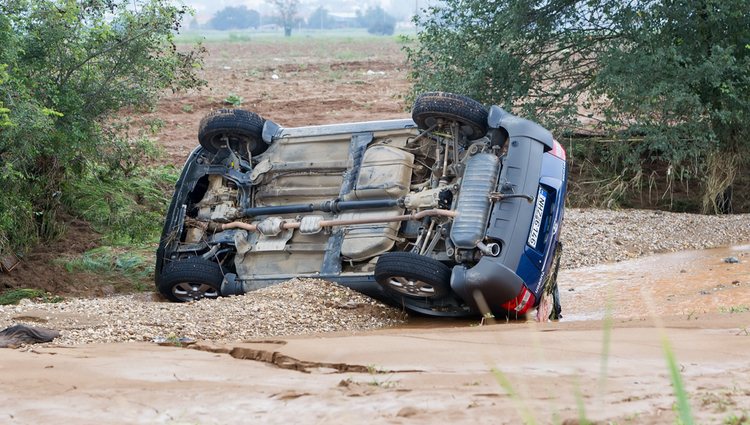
[{"x1": 155, "y1": 92, "x2": 566, "y2": 320}]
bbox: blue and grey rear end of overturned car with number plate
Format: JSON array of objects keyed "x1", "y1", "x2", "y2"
[{"x1": 451, "y1": 132, "x2": 566, "y2": 315}]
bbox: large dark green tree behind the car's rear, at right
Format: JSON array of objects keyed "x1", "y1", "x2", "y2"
[{"x1": 406, "y1": 0, "x2": 750, "y2": 212}]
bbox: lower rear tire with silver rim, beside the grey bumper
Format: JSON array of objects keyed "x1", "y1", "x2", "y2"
[{"x1": 375, "y1": 252, "x2": 451, "y2": 299}]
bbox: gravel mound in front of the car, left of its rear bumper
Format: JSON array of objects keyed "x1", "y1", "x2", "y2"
[{"x1": 0, "y1": 279, "x2": 406, "y2": 344}]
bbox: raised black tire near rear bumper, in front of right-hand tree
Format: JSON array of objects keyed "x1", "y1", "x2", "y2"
[{"x1": 411, "y1": 92, "x2": 488, "y2": 140}]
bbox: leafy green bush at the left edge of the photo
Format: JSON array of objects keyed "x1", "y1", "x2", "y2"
[{"x1": 0, "y1": 0, "x2": 202, "y2": 249}]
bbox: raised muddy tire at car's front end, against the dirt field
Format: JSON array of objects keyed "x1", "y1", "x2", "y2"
[{"x1": 198, "y1": 109, "x2": 268, "y2": 156}]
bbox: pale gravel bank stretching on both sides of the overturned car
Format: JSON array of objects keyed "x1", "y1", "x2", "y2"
[{"x1": 0, "y1": 209, "x2": 750, "y2": 344}]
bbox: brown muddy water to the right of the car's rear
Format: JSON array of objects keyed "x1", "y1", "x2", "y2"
[{"x1": 558, "y1": 245, "x2": 750, "y2": 321}]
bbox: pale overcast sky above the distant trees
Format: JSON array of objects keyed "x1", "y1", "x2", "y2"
[{"x1": 183, "y1": 0, "x2": 428, "y2": 20}]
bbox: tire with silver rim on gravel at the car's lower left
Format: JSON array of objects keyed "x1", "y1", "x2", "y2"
[{"x1": 159, "y1": 257, "x2": 224, "y2": 302}]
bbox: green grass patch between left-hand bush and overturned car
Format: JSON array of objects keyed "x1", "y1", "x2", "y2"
[{"x1": 55, "y1": 153, "x2": 179, "y2": 292}]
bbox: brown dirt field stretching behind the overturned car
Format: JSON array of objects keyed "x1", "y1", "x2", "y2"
[{"x1": 143, "y1": 37, "x2": 409, "y2": 164}]
